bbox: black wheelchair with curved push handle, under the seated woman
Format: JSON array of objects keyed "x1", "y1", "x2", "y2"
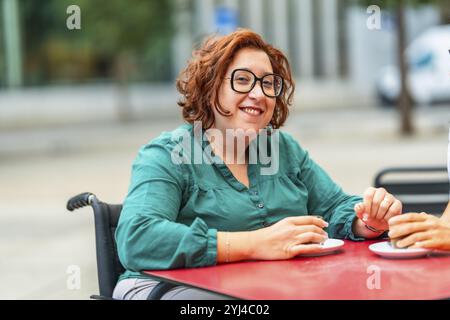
[{"x1": 67, "y1": 192, "x2": 175, "y2": 300}]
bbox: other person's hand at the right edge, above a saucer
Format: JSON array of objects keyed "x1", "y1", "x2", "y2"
[{"x1": 389, "y1": 212, "x2": 450, "y2": 250}]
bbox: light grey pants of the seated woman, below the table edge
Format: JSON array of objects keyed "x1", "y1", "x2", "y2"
[{"x1": 113, "y1": 278, "x2": 232, "y2": 300}]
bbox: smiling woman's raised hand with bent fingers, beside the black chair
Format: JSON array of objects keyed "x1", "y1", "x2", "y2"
[{"x1": 355, "y1": 187, "x2": 402, "y2": 234}]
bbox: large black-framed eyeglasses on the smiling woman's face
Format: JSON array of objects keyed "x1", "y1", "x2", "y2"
[{"x1": 225, "y1": 69, "x2": 284, "y2": 98}]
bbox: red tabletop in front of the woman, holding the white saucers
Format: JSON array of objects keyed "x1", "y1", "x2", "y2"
[{"x1": 146, "y1": 241, "x2": 450, "y2": 300}]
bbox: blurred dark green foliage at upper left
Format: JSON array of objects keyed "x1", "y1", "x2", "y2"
[{"x1": 19, "y1": 0, "x2": 173, "y2": 85}]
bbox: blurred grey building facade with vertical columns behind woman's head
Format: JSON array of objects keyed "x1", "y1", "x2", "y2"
[{"x1": 173, "y1": 0, "x2": 441, "y2": 86}]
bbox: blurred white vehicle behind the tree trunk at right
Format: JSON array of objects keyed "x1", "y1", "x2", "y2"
[{"x1": 376, "y1": 25, "x2": 450, "y2": 105}]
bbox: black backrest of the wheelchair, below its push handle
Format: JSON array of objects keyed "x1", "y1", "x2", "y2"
[{"x1": 91, "y1": 198, "x2": 125, "y2": 297}]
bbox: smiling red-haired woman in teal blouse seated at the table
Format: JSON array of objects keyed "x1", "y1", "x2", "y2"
[{"x1": 114, "y1": 30, "x2": 401, "y2": 299}]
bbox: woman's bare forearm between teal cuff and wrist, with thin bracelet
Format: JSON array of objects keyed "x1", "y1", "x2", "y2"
[{"x1": 217, "y1": 231, "x2": 254, "y2": 263}]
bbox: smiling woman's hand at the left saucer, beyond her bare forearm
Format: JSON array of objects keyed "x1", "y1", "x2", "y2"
[{"x1": 251, "y1": 216, "x2": 328, "y2": 260}]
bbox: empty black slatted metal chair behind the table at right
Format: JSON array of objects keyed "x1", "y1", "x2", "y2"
[{"x1": 375, "y1": 166, "x2": 450, "y2": 215}]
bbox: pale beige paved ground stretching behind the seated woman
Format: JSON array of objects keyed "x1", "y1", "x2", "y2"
[{"x1": 0, "y1": 106, "x2": 450, "y2": 299}]
